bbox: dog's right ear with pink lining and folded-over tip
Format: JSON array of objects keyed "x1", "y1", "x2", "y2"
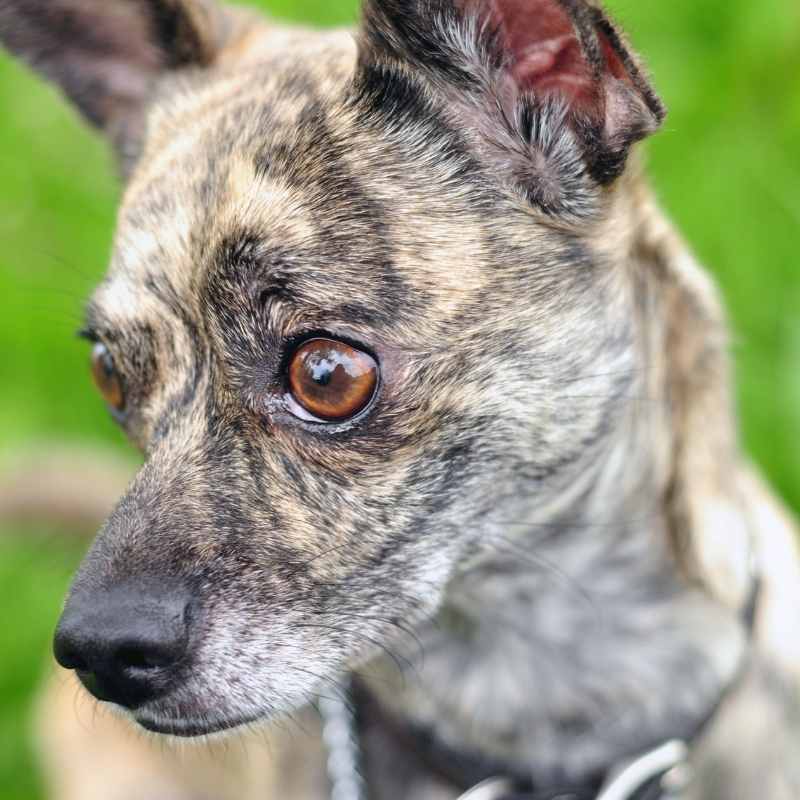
[{"x1": 361, "y1": 0, "x2": 665, "y2": 216}]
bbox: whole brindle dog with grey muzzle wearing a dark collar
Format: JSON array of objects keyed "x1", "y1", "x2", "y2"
[{"x1": 0, "y1": 0, "x2": 800, "y2": 800}]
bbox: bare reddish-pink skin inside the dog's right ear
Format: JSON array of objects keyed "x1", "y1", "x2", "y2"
[{"x1": 489, "y1": 0, "x2": 600, "y2": 114}]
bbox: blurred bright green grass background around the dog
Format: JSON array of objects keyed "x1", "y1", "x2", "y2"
[{"x1": 0, "y1": 0, "x2": 800, "y2": 800}]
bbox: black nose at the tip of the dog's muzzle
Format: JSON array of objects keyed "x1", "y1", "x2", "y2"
[{"x1": 53, "y1": 581, "x2": 189, "y2": 709}]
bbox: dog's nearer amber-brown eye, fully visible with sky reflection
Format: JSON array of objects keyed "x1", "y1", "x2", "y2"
[{"x1": 289, "y1": 339, "x2": 378, "y2": 422}]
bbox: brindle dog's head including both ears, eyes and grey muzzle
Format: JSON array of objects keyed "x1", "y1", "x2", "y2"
[{"x1": 0, "y1": 0, "x2": 662, "y2": 735}]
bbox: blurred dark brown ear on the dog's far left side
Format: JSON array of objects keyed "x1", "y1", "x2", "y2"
[{"x1": 0, "y1": 0, "x2": 230, "y2": 166}]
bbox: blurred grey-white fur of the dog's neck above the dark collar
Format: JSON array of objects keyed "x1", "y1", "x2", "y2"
[{"x1": 360, "y1": 186, "x2": 747, "y2": 784}]
